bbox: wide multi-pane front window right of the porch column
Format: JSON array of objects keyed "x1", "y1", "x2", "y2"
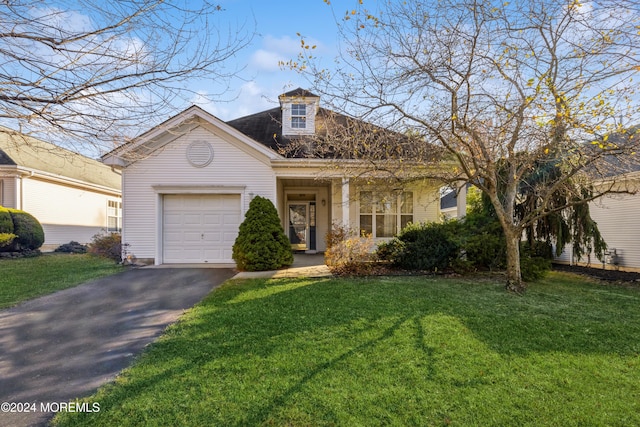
[{"x1": 360, "y1": 191, "x2": 413, "y2": 238}]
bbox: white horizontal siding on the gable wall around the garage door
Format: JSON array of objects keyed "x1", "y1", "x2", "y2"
[{"x1": 122, "y1": 127, "x2": 276, "y2": 264}]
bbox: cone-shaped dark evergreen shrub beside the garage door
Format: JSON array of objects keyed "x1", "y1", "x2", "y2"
[{"x1": 232, "y1": 196, "x2": 293, "y2": 271}]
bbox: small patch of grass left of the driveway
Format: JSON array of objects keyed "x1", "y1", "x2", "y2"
[{"x1": 0, "y1": 253, "x2": 124, "y2": 308}]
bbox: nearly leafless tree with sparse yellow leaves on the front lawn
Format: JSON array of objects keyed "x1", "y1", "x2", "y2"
[{"x1": 288, "y1": 0, "x2": 640, "y2": 292}]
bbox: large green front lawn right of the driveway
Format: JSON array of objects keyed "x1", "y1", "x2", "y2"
[{"x1": 56, "y1": 273, "x2": 640, "y2": 427}]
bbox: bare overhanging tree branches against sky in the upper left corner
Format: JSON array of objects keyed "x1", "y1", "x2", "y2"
[{"x1": 0, "y1": 0, "x2": 252, "y2": 156}]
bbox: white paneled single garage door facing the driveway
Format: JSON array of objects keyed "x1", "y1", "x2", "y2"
[{"x1": 162, "y1": 194, "x2": 241, "y2": 263}]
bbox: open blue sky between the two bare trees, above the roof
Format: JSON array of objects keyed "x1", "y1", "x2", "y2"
[{"x1": 189, "y1": 0, "x2": 358, "y2": 120}]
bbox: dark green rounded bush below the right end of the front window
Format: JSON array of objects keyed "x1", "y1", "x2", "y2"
[{"x1": 377, "y1": 221, "x2": 460, "y2": 271}]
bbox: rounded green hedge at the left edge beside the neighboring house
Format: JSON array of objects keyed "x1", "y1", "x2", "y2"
[{"x1": 0, "y1": 207, "x2": 44, "y2": 251}]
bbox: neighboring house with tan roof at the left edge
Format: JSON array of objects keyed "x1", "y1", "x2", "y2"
[{"x1": 0, "y1": 127, "x2": 122, "y2": 251}]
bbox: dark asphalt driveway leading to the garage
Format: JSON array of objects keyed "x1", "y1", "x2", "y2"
[{"x1": 0, "y1": 268, "x2": 234, "y2": 427}]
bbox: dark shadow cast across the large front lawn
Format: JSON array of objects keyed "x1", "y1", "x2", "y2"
[{"x1": 61, "y1": 278, "x2": 640, "y2": 425}]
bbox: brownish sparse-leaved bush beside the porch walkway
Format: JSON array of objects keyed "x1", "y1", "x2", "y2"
[{"x1": 324, "y1": 224, "x2": 376, "y2": 276}]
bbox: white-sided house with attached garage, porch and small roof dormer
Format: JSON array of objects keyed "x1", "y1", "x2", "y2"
[{"x1": 103, "y1": 89, "x2": 460, "y2": 265}]
